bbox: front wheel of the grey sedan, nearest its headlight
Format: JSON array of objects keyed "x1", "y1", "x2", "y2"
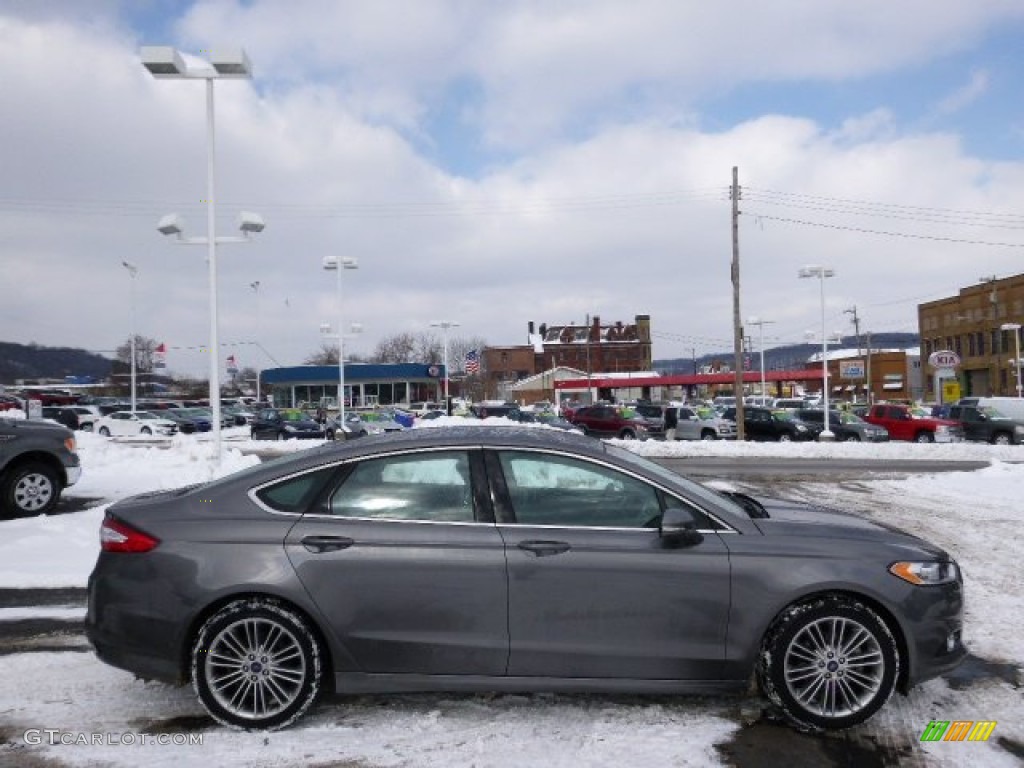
[{"x1": 757, "y1": 596, "x2": 900, "y2": 729}]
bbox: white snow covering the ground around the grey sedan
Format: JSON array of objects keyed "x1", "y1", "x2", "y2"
[{"x1": 0, "y1": 428, "x2": 1024, "y2": 768}]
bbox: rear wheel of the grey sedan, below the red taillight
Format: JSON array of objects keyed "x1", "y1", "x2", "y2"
[{"x1": 191, "y1": 598, "x2": 324, "y2": 730}]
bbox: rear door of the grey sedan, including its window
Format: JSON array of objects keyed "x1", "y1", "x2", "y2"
[{"x1": 286, "y1": 450, "x2": 508, "y2": 676}]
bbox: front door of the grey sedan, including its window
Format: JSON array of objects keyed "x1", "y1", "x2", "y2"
[{"x1": 487, "y1": 450, "x2": 730, "y2": 680}]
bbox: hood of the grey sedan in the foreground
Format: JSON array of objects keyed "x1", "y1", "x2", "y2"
[{"x1": 753, "y1": 499, "x2": 948, "y2": 558}]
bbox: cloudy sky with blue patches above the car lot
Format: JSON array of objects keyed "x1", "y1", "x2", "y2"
[{"x1": 0, "y1": 0, "x2": 1024, "y2": 374}]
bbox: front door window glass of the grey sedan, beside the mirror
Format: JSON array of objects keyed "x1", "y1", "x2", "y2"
[{"x1": 500, "y1": 451, "x2": 662, "y2": 528}]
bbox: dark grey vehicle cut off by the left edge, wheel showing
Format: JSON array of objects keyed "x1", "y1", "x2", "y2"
[{"x1": 0, "y1": 417, "x2": 82, "y2": 519}]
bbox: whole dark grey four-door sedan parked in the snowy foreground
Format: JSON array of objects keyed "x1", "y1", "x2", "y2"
[{"x1": 85, "y1": 426, "x2": 967, "y2": 729}]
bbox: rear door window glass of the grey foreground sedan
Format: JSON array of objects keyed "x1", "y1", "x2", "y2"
[{"x1": 329, "y1": 451, "x2": 473, "y2": 522}]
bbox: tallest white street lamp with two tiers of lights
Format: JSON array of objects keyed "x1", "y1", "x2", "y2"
[{"x1": 141, "y1": 45, "x2": 264, "y2": 464}]
